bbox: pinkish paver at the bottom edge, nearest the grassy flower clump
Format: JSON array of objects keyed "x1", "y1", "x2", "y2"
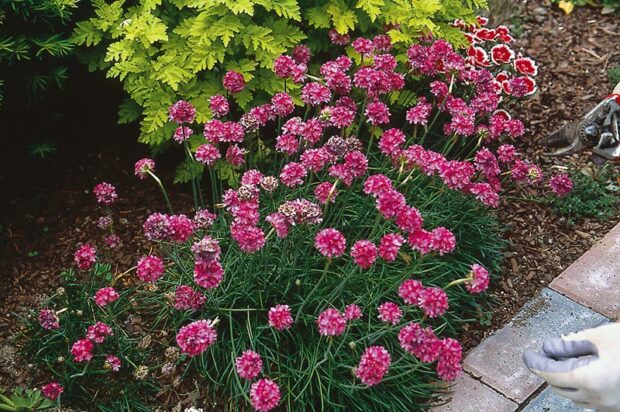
[{"x1": 430, "y1": 373, "x2": 518, "y2": 412}]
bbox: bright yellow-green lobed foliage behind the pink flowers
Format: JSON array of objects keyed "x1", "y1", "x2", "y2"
[{"x1": 74, "y1": 0, "x2": 487, "y2": 150}]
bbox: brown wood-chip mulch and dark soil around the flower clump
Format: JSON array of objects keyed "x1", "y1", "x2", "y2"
[{"x1": 0, "y1": 0, "x2": 620, "y2": 394}]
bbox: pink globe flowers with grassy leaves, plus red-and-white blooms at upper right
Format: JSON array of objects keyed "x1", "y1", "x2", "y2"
[{"x1": 31, "y1": 18, "x2": 570, "y2": 411}]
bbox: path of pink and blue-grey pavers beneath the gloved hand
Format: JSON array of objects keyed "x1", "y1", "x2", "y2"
[{"x1": 431, "y1": 224, "x2": 620, "y2": 412}]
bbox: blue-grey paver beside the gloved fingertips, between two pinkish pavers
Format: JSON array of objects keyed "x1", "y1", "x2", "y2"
[{"x1": 464, "y1": 288, "x2": 607, "y2": 406}]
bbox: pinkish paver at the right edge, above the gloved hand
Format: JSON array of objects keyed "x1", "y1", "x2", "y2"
[{"x1": 549, "y1": 224, "x2": 620, "y2": 319}]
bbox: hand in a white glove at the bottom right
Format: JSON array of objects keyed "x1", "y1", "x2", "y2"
[{"x1": 523, "y1": 323, "x2": 620, "y2": 412}]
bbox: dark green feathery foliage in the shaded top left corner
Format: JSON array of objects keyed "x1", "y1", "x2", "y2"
[{"x1": 0, "y1": 0, "x2": 78, "y2": 104}]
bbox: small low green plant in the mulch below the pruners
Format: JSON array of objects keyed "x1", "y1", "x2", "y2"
[{"x1": 551, "y1": 167, "x2": 620, "y2": 222}]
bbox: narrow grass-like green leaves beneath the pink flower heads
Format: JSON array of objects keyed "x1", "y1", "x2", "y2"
[{"x1": 21, "y1": 176, "x2": 503, "y2": 411}]
